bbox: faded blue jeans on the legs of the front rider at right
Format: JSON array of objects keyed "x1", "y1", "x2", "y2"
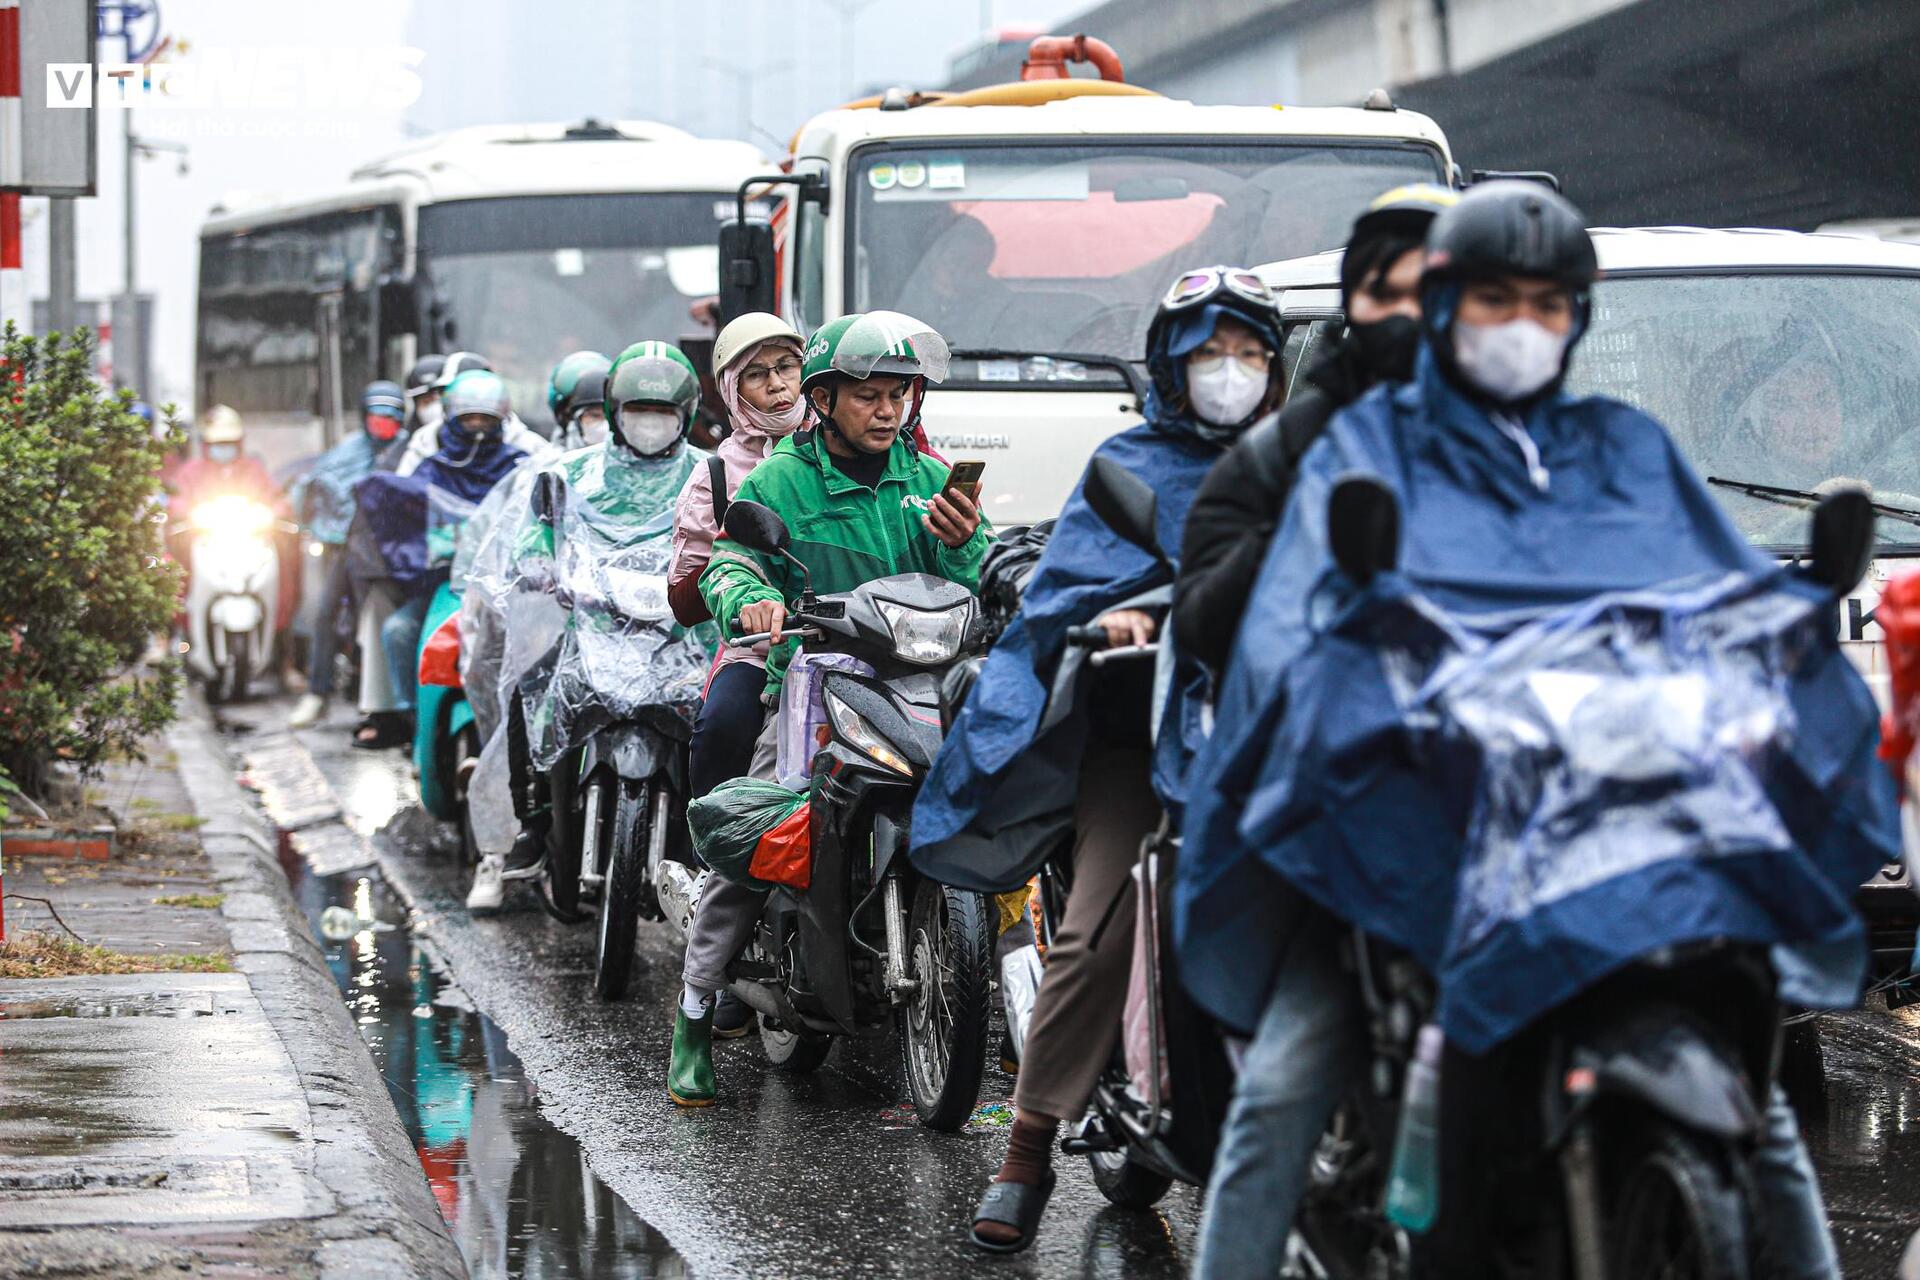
[{"x1": 1194, "y1": 912, "x2": 1839, "y2": 1280}]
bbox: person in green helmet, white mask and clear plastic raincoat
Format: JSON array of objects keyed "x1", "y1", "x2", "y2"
[{"x1": 467, "y1": 342, "x2": 705, "y2": 912}]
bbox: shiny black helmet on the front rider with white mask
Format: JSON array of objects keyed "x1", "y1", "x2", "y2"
[{"x1": 1421, "y1": 178, "x2": 1599, "y2": 397}]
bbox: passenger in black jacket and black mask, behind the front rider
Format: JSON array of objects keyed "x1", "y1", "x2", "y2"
[{"x1": 1173, "y1": 184, "x2": 1459, "y2": 677}]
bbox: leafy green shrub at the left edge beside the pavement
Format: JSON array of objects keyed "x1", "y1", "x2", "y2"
[{"x1": 0, "y1": 324, "x2": 180, "y2": 793}]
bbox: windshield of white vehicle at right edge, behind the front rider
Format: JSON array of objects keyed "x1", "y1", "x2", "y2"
[{"x1": 1567, "y1": 274, "x2": 1920, "y2": 549}]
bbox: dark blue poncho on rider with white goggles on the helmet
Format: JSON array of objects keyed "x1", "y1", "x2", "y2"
[{"x1": 912, "y1": 305, "x2": 1279, "y2": 892}]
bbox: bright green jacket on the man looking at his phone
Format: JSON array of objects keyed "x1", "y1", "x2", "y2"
[{"x1": 701, "y1": 430, "x2": 993, "y2": 700}]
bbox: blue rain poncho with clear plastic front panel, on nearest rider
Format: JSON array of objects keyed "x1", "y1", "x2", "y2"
[{"x1": 1175, "y1": 353, "x2": 1899, "y2": 1052}]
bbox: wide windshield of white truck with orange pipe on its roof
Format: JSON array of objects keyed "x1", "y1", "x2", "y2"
[{"x1": 847, "y1": 140, "x2": 1442, "y2": 382}]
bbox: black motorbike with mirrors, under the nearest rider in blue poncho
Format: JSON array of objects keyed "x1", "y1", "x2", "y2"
[{"x1": 1283, "y1": 478, "x2": 1872, "y2": 1280}]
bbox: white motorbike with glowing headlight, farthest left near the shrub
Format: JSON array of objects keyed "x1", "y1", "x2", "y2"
[{"x1": 169, "y1": 493, "x2": 292, "y2": 702}]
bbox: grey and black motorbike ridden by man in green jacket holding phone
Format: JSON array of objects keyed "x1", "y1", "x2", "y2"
[{"x1": 655, "y1": 501, "x2": 996, "y2": 1132}]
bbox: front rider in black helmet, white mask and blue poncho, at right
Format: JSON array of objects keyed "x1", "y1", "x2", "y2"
[{"x1": 1173, "y1": 182, "x2": 1899, "y2": 1276}]
